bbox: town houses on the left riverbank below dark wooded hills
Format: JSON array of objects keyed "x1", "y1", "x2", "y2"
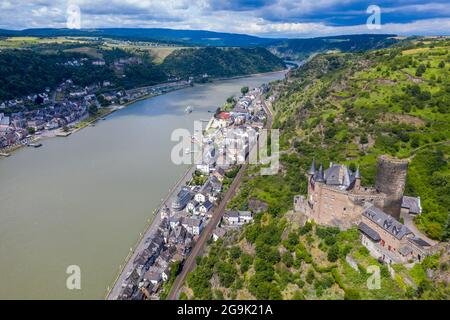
[{"x1": 0, "y1": 75, "x2": 188, "y2": 149}]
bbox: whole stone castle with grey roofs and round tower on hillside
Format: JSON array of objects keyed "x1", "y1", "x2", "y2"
[{"x1": 294, "y1": 156, "x2": 431, "y2": 263}]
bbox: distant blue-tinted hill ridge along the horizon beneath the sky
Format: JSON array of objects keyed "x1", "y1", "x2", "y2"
[{"x1": 0, "y1": 28, "x2": 398, "y2": 59}]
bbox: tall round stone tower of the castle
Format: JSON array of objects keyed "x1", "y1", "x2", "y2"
[{"x1": 375, "y1": 155, "x2": 408, "y2": 220}]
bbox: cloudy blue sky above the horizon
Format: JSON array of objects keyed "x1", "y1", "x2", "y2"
[{"x1": 0, "y1": 0, "x2": 450, "y2": 37}]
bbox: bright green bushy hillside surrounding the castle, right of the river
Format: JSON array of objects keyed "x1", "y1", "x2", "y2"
[{"x1": 181, "y1": 40, "x2": 450, "y2": 300}]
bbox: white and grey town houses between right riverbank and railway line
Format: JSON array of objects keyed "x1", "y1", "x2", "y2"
[{"x1": 119, "y1": 84, "x2": 270, "y2": 299}]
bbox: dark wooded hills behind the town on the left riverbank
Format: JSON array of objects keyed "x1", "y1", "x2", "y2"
[{"x1": 0, "y1": 44, "x2": 285, "y2": 101}]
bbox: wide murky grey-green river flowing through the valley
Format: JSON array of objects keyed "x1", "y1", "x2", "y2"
[{"x1": 0, "y1": 72, "x2": 284, "y2": 299}]
